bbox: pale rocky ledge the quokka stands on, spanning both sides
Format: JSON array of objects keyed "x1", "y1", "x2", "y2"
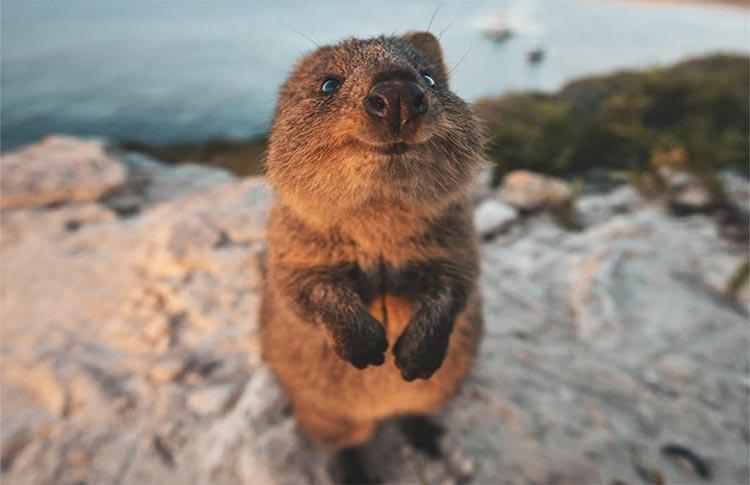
[{"x1": 0, "y1": 137, "x2": 750, "y2": 484}]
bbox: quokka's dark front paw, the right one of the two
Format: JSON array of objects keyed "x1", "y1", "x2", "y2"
[{"x1": 393, "y1": 320, "x2": 450, "y2": 381}]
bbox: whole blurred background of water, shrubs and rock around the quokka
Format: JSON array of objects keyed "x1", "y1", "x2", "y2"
[{"x1": 0, "y1": 0, "x2": 750, "y2": 485}]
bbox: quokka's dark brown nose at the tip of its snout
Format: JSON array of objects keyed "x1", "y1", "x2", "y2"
[{"x1": 364, "y1": 79, "x2": 428, "y2": 135}]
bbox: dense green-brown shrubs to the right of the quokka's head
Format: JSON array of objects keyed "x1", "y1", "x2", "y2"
[{"x1": 477, "y1": 55, "x2": 750, "y2": 182}]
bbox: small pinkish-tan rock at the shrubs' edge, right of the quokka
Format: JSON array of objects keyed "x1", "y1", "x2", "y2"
[{"x1": 497, "y1": 170, "x2": 572, "y2": 211}]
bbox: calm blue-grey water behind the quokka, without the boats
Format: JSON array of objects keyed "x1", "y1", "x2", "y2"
[{"x1": 0, "y1": 0, "x2": 749, "y2": 150}]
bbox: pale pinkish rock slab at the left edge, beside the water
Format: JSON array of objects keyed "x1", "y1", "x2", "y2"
[{"x1": 0, "y1": 136, "x2": 126, "y2": 209}]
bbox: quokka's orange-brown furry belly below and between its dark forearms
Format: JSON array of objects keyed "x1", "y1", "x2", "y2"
[{"x1": 263, "y1": 295, "x2": 482, "y2": 421}]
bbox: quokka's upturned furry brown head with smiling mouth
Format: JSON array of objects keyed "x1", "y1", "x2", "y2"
[{"x1": 267, "y1": 32, "x2": 482, "y2": 217}]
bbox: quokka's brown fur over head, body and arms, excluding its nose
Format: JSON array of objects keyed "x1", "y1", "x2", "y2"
[{"x1": 261, "y1": 33, "x2": 483, "y2": 449}]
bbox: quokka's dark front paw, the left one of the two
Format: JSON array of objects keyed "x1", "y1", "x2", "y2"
[{"x1": 329, "y1": 312, "x2": 388, "y2": 369}]
